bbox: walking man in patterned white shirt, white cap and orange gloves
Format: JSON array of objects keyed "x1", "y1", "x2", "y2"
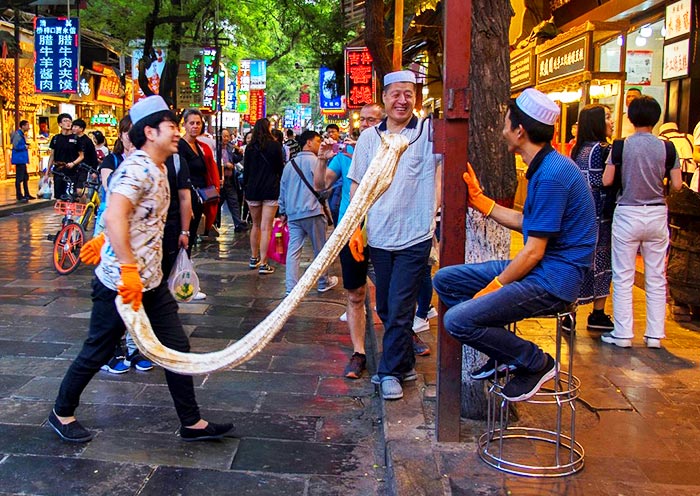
[{"x1": 48, "y1": 96, "x2": 233, "y2": 443}]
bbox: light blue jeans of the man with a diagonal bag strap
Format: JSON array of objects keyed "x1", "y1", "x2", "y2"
[{"x1": 284, "y1": 215, "x2": 328, "y2": 293}]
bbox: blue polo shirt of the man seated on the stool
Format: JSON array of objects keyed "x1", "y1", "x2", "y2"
[{"x1": 523, "y1": 145, "x2": 597, "y2": 302}]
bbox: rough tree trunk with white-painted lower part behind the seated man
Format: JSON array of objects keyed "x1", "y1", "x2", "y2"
[{"x1": 462, "y1": 0, "x2": 517, "y2": 419}]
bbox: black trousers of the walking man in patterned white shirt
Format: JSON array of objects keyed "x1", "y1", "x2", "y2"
[{"x1": 54, "y1": 277, "x2": 201, "y2": 426}]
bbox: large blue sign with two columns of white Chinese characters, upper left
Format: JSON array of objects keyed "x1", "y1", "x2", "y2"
[{"x1": 34, "y1": 17, "x2": 80, "y2": 93}]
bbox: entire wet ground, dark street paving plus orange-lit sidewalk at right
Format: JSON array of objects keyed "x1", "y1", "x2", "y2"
[{"x1": 0, "y1": 182, "x2": 700, "y2": 496}]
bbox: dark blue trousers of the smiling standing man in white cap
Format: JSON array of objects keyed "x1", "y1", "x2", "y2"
[{"x1": 370, "y1": 239, "x2": 432, "y2": 377}]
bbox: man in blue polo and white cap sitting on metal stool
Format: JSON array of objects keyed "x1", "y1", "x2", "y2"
[{"x1": 433, "y1": 89, "x2": 596, "y2": 401}]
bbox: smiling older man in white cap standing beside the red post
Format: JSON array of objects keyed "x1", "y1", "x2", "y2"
[{"x1": 348, "y1": 71, "x2": 441, "y2": 400}]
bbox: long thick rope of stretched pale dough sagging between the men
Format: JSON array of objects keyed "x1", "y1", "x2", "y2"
[{"x1": 116, "y1": 134, "x2": 410, "y2": 375}]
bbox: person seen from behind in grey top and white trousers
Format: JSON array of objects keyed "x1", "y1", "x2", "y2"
[{"x1": 601, "y1": 96, "x2": 682, "y2": 348}]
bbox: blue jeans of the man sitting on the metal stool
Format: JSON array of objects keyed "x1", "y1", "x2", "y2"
[{"x1": 433, "y1": 260, "x2": 567, "y2": 372}]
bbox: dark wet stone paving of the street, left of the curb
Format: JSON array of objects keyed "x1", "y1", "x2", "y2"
[{"x1": 0, "y1": 203, "x2": 387, "y2": 496}]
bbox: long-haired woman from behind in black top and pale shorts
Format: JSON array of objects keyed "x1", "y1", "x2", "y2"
[{"x1": 243, "y1": 119, "x2": 284, "y2": 274}]
